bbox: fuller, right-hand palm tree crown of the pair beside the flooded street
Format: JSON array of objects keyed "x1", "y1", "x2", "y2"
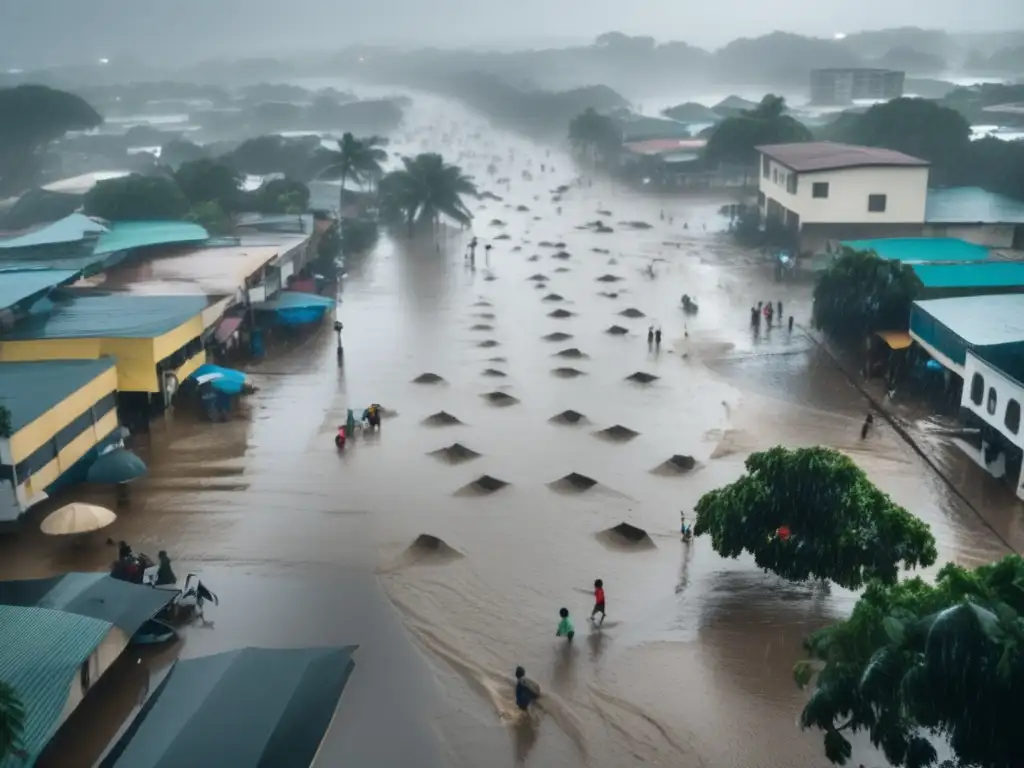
[{"x1": 380, "y1": 153, "x2": 479, "y2": 234}]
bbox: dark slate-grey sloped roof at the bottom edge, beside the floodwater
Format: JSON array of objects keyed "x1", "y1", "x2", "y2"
[{"x1": 100, "y1": 646, "x2": 355, "y2": 768}]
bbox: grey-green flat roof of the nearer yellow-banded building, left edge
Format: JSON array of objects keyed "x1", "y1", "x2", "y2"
[{"x1": 0, "y1": 357, "x2": 115, "y2": 432}]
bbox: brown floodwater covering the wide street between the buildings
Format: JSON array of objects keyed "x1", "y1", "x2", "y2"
[{"x1": 0, "y1": 91, "x2": 1019, "y2": 768}]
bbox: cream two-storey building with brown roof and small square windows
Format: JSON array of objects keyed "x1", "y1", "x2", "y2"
[{"x1": 758, "y1": 141, "x2": 929, "y2": 253}]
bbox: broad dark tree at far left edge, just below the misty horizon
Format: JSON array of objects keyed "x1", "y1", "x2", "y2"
[{"x1": 0, "y1": 85, "x2": 103, "y2": 196}]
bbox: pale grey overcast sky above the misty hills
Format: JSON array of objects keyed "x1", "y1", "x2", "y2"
[{"x1": 0, "y1": 0, "x2": 1024, "y2": 67}]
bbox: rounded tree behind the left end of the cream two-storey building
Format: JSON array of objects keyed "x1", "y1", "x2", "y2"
[{"x1": 703, "y1": 93, "x2": 812, "y2": 166}]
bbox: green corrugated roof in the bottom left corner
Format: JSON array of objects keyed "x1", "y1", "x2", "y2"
[{"x1": 0, "y1": 605, "x2": 113, "y2": 768}]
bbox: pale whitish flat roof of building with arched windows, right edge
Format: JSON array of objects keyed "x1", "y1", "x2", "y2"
[{"x1": 910, "y1": 294, "x2": 1024, "y2": 347}]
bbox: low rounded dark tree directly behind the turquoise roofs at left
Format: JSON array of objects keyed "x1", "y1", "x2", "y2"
[{"x1": 82, "y1": 174, "x2": 189, "y2": 221}]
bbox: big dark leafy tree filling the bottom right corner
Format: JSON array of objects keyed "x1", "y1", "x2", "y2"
[{"x1": 795, "y1": 555, "x2": 1024, "y2": 768}]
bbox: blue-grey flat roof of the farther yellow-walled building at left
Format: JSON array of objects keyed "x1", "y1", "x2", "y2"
[{"x1": 4, "y1": 292, "x2": 207, "y2": 341}]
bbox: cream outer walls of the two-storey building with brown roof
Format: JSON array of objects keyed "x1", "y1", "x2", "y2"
[{"x1": 759, "y1": 160, "x2": 928, "y2": 224}]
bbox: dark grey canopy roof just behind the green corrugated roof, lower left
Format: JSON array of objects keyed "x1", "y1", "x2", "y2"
[{"x1": 0, "y1": 573, "x2": 177, "y2": 637}]
